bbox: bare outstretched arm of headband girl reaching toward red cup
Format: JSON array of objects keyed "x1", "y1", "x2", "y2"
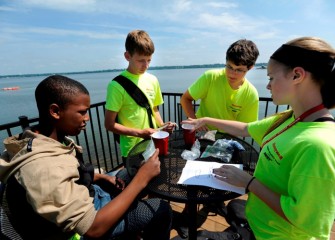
[{"x1": 182, "y1": 117, "x2": 250, "y2": 137}]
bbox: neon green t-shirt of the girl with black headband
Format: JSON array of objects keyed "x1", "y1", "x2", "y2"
[{"x1": 246, "y1": 116, "x2": 335, "y2": 239}]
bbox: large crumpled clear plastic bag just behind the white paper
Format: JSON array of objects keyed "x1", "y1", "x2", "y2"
[{"x1": 200, "y1": 139, "x2": 245, "y2": 163}]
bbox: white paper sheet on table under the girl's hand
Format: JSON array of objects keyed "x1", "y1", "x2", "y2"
[{"x1": 178, "y1": 161, "x2": 245, "y2": 194}]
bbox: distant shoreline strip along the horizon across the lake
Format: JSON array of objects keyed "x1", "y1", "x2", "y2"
[{"x1": 0, "y1": 63, "x2": 267, "y2": 78}]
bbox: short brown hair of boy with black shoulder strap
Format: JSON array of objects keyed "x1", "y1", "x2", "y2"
[{"x1": 125, "y1": 30, "x2": 155, "y2": 56}]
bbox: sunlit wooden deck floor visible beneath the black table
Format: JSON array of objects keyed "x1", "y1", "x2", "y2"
[{"x1": 170, "y1": 195, "x2": 335, "y2": 240}]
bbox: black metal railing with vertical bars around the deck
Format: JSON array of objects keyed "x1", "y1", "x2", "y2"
[{"x1": 0, "y1": 93, "x2": 288, "y2": 171}]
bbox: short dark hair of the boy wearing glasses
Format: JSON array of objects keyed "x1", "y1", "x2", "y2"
[{"x1": 226, "y1": 39, "x2": 259, "y2": 68}]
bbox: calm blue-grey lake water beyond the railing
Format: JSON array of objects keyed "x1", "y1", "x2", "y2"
[{"x1": 0, "y1": 68, "x2": 270, "y2": 125}]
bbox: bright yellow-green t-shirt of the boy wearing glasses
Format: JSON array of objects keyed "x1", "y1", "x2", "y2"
[{"x1": 188, "y1": 69, "x2": 259, "y2": 129}]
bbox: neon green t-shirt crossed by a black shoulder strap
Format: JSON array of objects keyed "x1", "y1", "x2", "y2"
[{"x1": 106, "y1": 70, "x2": 164, "y2": 157}]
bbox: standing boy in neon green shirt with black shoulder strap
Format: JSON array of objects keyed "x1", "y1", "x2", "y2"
[{"x1": 105, "y1": 30, "x2": 174, "y2": 157}]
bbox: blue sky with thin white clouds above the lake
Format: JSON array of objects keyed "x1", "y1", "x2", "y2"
[{"x1": 0, "y1": 0, "x2": 335, "y2": 75}]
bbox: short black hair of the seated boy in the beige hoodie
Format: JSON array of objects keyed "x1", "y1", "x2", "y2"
[{"x1": 35, "y1": 75, "x2": 89, "y2": 118}]
